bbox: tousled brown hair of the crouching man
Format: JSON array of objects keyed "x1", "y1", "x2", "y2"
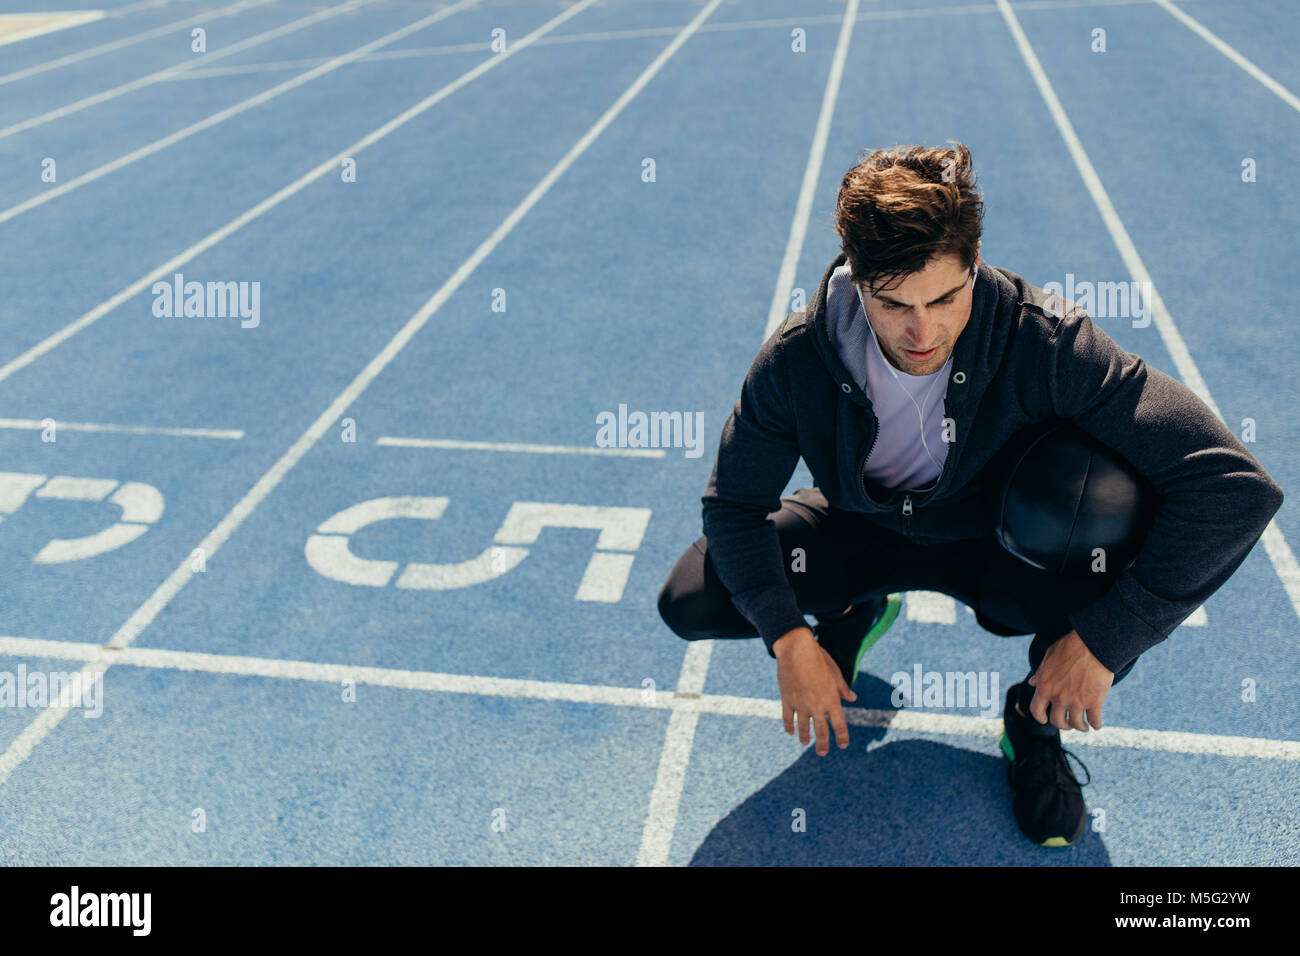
[{"x1": 835, "y1": 140, "x2": 984, "y2": 291}]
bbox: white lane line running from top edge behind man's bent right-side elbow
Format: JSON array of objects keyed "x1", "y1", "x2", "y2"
[{"x1": 997, "y1": 0, "x2": 1300, "y2": 632}]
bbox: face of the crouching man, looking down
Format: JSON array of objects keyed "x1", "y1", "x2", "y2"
[{"x1": 858, "y1": 252, "x2": 979, "y2": 375}]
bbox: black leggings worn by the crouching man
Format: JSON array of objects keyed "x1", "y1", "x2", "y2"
[{"x1": 659, "y1": 488, "x2": 1136, "y2": 683}]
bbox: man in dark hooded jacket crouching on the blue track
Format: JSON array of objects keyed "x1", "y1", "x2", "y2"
[{"x1": 659, "y1": 143, "x2": 1283, "y2": 847}]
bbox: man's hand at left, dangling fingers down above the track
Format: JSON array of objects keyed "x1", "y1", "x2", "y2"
[{"x1": 772, "y1": 627, "x2": 858, "y2": 757}]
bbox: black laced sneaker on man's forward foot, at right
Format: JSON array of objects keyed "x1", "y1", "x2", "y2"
[{"x1": 1000, "y1": 684, "x2": 1092, "y2": 847}]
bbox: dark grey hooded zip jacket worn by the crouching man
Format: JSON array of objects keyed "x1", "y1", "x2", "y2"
[{"x1": 702, "y1": 252, "x2": 1283, "y2": 671}]
